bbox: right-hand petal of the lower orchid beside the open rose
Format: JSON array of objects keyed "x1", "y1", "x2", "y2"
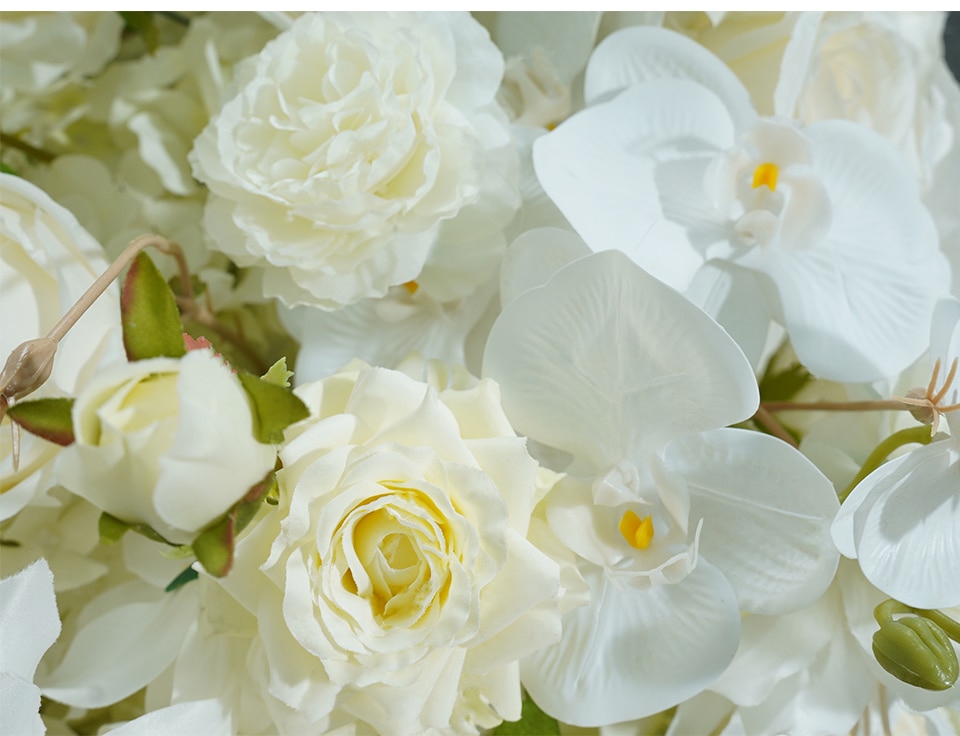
[{"x1": 665, "y1": 429, "x2": 839, "y2": 615}]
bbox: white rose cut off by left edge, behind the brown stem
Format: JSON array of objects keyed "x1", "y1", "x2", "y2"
[{"x1": 0, "y1": 174, "x2": 123, "y2": 519}]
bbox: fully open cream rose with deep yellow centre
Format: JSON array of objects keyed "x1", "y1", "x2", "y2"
[{"x1": 182, "y1": 361, "x2": 560, "y2": 733}]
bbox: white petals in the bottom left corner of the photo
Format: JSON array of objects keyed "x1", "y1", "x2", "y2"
[{"x1": 0, "y1": 560, "x2": 60, "y2": 736}]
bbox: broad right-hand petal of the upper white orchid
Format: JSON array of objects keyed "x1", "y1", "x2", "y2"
[{"x1": 739, "y1": 121, "x2": 950, "y2": 383}]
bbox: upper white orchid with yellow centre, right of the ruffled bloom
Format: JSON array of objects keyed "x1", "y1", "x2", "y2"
[{"x1": 534, "y1": 27, "x2": 950, "y2": 382}]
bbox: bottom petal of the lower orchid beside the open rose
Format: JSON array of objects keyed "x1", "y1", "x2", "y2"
[{"x1": 520, "y1": 560, "x2": 740, "y2": 726}]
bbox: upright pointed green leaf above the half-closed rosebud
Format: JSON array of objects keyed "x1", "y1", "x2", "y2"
[{"x1": 120, "y1": 253, "x2": 187, "y2": 360}]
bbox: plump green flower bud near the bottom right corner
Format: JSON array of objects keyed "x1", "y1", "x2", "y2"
[{"x1": 873, "y1": 616, "x2": 958, "y2": 690}]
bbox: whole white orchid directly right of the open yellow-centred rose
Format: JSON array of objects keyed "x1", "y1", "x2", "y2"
[{"x1": 484, "y1": 252, "x2": 838, "y2": 726}]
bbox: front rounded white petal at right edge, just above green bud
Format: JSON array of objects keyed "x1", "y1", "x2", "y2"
[{"x1": 844, "y1": 441, "x2": 960, "y2": 608}]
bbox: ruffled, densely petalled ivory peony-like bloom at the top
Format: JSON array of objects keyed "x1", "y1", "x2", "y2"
[{"x1": 190, "y1": 13, "x2": 516, "y2": 309}]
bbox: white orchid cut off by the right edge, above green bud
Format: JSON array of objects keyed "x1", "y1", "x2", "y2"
[{"x1": 833, "y1": 298, "x2": 960, "y2": 608}]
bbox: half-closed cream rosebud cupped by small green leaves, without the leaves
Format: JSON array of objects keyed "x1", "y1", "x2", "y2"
[{"x1": 58, "y1": 350, "x2": 276, "y2": 543}]
